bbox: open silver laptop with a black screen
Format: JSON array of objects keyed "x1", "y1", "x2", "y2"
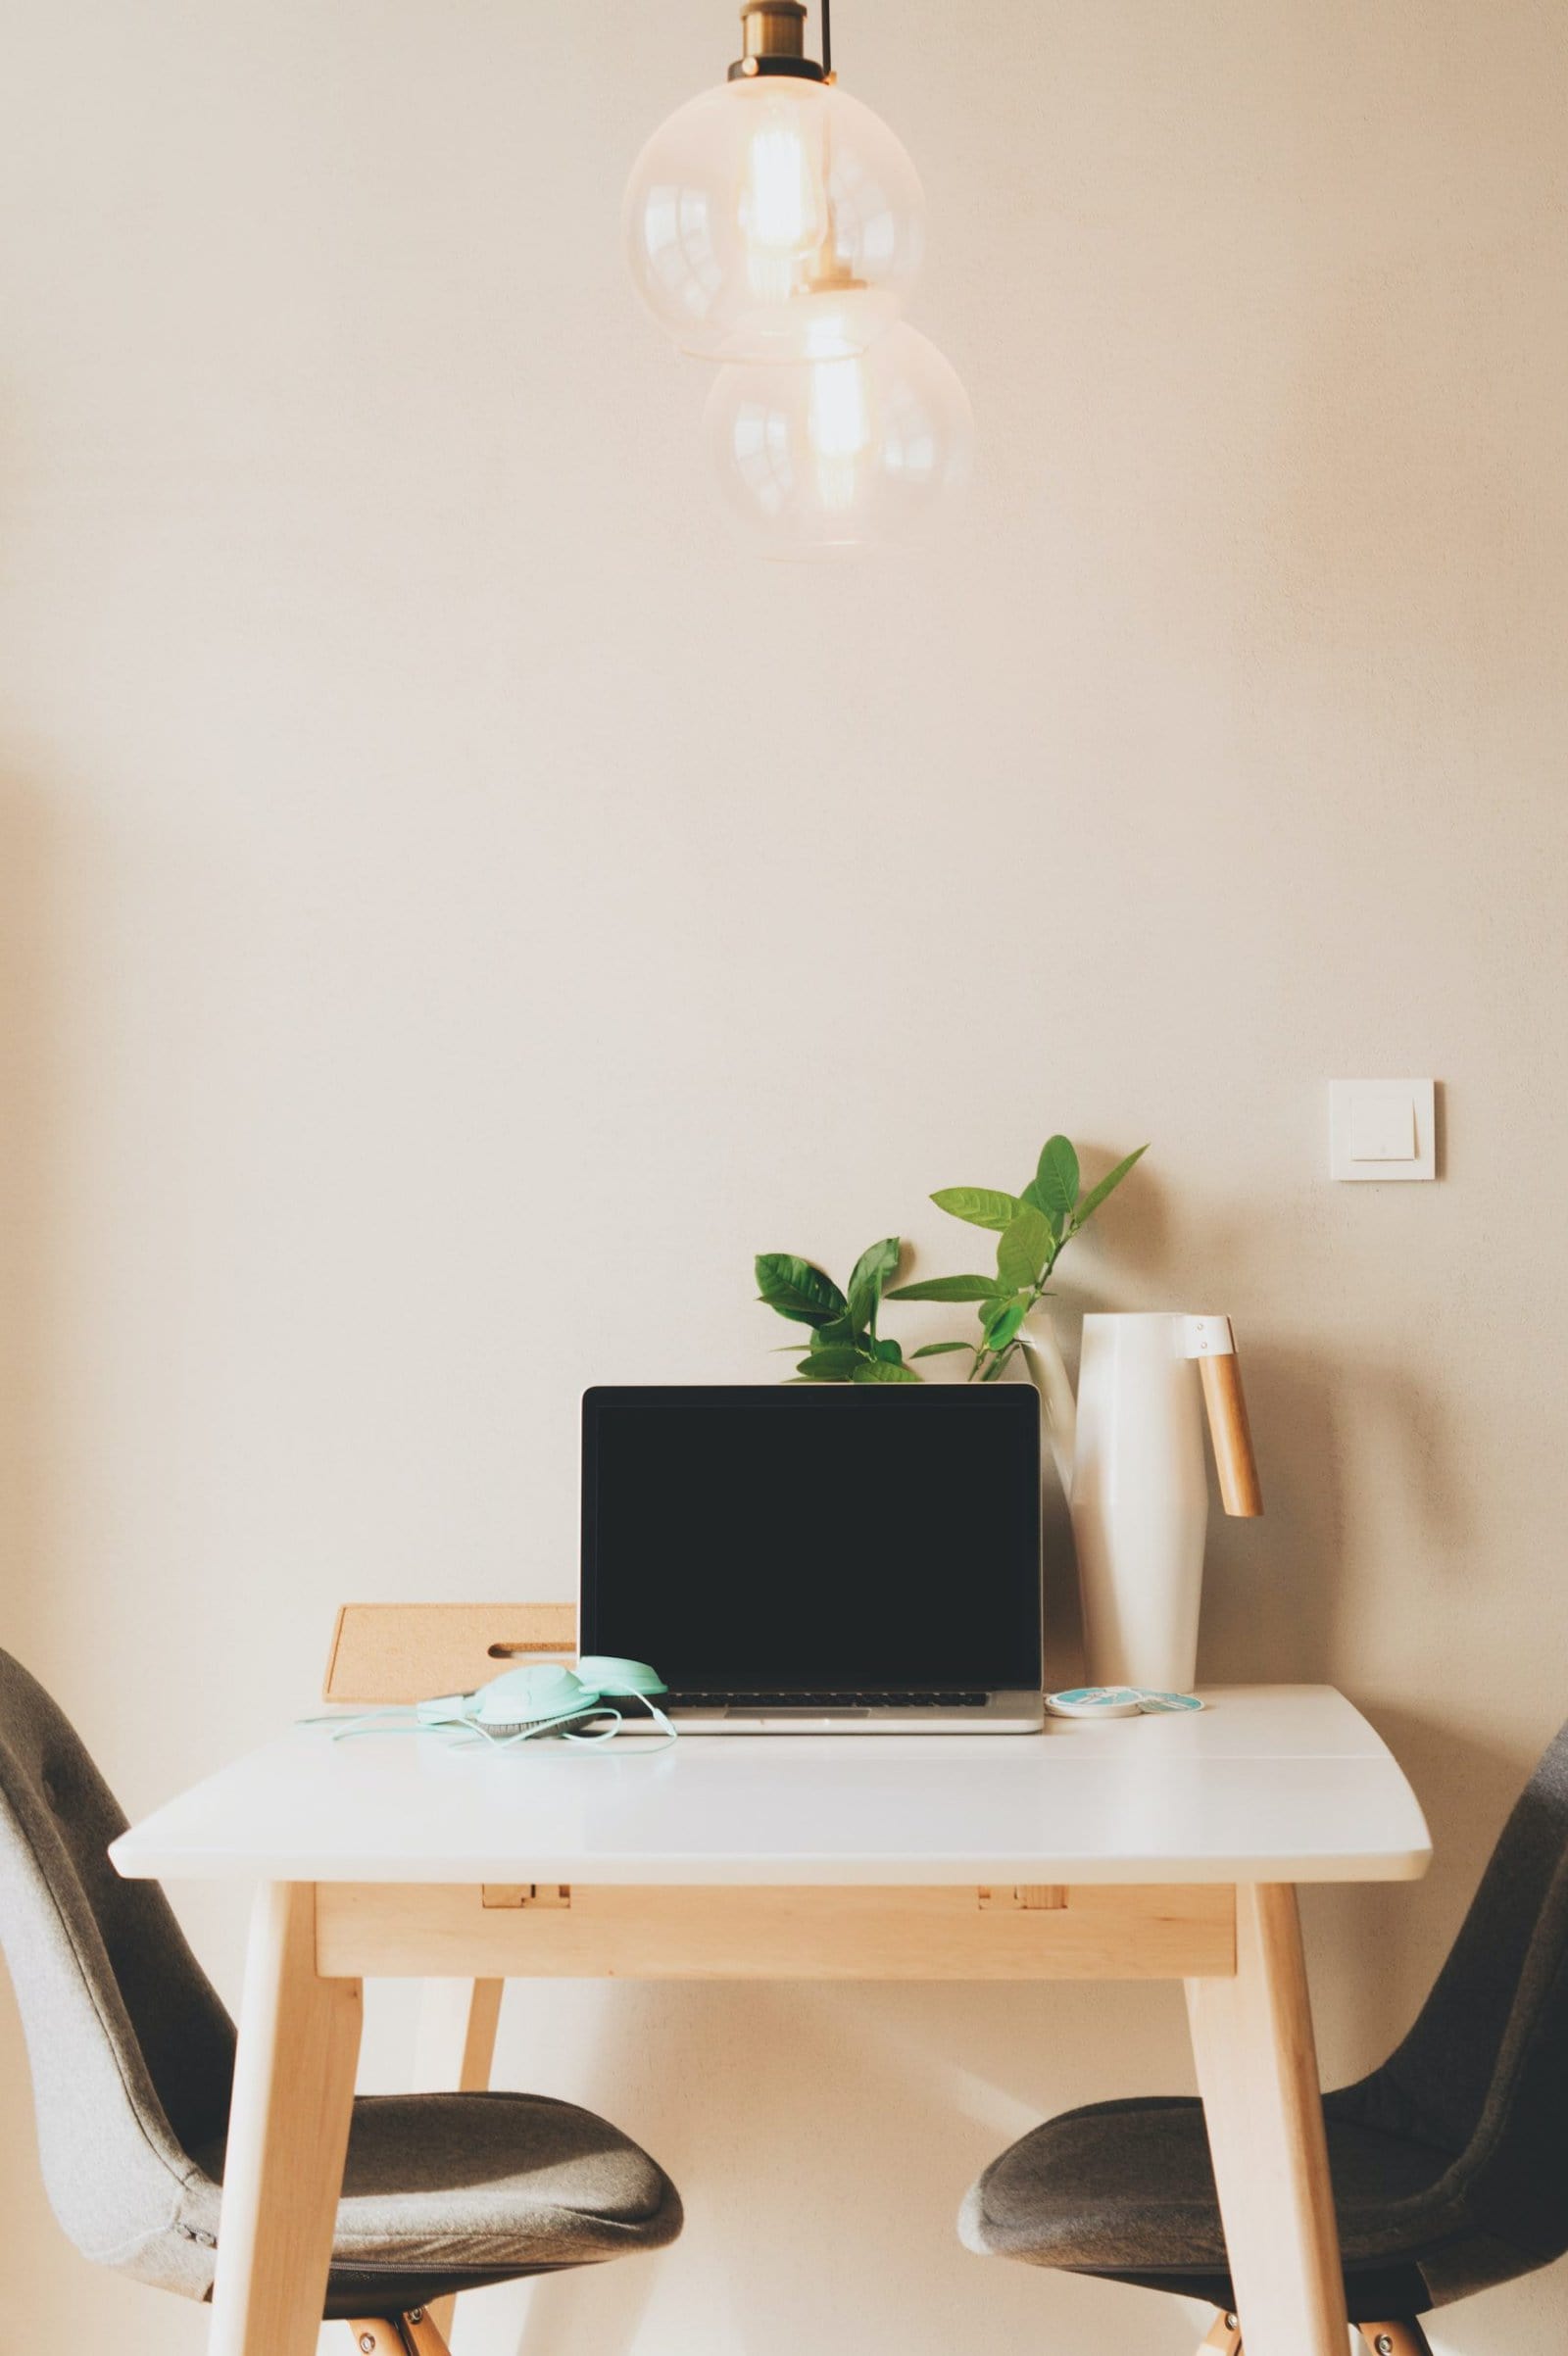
[{"x1": 579, "y1": 1383, "x2": 1043, "y2": 1734}]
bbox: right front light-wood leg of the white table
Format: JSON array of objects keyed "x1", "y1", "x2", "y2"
[{"x1": 1187, "y1": 1883, "x2": 1349, "y2": 2356}]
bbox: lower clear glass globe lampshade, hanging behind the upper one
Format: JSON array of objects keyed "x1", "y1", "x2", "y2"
[{"x1": 707, "y1": 322, "x2": 975, "y2": 559}]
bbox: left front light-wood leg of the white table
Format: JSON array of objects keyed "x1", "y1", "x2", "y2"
[{"x1": 210, "y1": 1883, "x2": 361, "y2": 2356}]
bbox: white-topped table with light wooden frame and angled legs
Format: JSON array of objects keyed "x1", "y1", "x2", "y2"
[{"x1": 113, "y1": 1687, "x2": 1429, "y2": 2356}]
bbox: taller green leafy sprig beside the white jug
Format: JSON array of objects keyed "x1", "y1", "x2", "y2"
[{"x1": 888, "y1": 1138, "x2": 1149, "y2": 1383}]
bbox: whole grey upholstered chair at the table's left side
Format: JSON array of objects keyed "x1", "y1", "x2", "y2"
[{"x1": 0, "y1": 1654, "x2": 680, "y2": 2356}]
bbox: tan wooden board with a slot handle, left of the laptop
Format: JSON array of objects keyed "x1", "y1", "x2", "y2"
[{"x1": 322, "y1": 1604, "x2": 577, "y2": 1703}]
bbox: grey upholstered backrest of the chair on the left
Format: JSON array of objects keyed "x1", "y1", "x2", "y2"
[{"x1": 0, "y1": 1651, "x2": 233, "y2": 2297}]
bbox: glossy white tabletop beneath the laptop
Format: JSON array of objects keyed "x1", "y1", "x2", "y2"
[{"x1": 111, "y1": 1685, "x2": 1432, "y2": 1885}]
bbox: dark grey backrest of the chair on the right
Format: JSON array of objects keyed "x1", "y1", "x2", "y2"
[{"x1": 1330, "y1": 1727, "x2": 1568, "y2": 2262}]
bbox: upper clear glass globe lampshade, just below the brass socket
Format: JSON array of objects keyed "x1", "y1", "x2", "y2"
[{"x1": 626, "y1": 75, "x2": 925, "y2": 361}]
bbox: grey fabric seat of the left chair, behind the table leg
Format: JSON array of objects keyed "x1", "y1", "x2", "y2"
[{"x1": 183, "y1": 2094, "x2": 680, "y2": 2314}]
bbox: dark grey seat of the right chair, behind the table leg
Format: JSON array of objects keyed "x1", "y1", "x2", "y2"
[{"x1": 958, "y1": 2097, "x2": 1459, "y2": 2279}]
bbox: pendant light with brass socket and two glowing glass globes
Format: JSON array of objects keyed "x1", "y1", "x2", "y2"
[{"x1": 626, "y1": 0, "x2": 972, "y2": 556}]
